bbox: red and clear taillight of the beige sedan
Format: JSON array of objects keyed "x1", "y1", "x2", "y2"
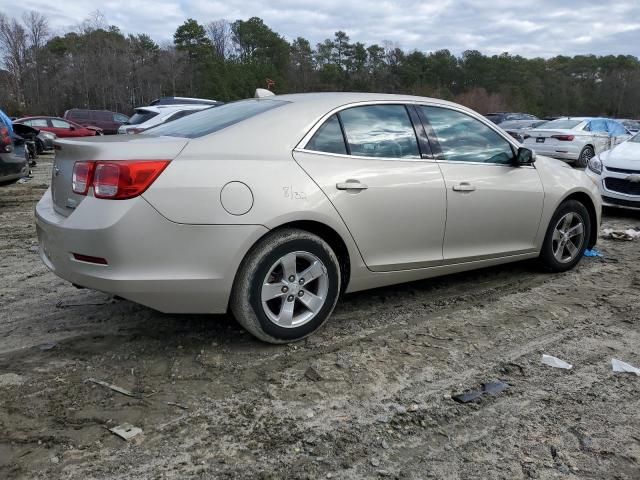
[{"x1": 73, "y1": 160, "x2": 169, "y2": 200}]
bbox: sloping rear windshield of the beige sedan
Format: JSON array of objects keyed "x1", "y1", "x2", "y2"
[{"x1": 144, "y1": 99, "x2": 289, "y2": 138}]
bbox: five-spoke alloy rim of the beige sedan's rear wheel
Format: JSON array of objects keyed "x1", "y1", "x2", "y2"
[{"x1": 261, "y1": 252, "x2": 329, "y2": 328}]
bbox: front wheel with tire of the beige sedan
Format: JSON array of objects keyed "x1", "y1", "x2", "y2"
[{"x1": 539, "y1": 200, "x2": 591, "y2": 272}]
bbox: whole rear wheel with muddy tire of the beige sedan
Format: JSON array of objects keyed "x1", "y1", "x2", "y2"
[{"x1": 230, "y1": 229, "x2": 341, "y2": 343}]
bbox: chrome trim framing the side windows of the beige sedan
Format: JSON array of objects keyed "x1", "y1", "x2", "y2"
[{"x1": 293, "y1": 100, "x2": 536, "y2": 169}]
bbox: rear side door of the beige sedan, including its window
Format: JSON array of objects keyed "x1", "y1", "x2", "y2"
[{"x1": 294, "y1": 104, "x2": 446, "y2": 271}]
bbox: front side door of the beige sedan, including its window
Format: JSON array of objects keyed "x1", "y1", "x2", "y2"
[{"x1": 418, "y1": 106, "x2": 544, "y2": 264}]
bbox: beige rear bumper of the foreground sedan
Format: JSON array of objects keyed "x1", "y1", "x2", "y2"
[{"x1": 36, "y1": 190, "x2": 267, "y2": 313}]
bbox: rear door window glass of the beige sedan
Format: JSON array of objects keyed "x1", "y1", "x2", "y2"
[{"x1": 339, "y1": 105, "x2": 420, "y2": 158}]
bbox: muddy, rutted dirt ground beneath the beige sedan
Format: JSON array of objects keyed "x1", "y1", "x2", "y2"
[{"x1": 0, "y1": 159, "x2": 640, "y2": 479}]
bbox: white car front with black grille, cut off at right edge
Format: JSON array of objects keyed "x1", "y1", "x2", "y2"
[{"x1": 587, "y1": 134, "x2": 640, "y2": 210}]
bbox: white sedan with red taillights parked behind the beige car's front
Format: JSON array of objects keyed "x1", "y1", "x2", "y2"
[{"x1": 522, "y1": 117, "x2": 630, "y2": 168}]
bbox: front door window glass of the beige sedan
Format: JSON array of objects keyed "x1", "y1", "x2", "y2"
[{"x1": 420, "y1": 106, "x2": 514, "y2": 164}]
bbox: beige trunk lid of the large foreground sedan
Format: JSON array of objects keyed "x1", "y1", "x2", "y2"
[{"x1": 51, "y1": 135, "x2": 189, "y2": 217}]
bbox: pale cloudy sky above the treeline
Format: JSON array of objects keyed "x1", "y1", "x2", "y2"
[{"x1": 5, "y1": 0, "x2": 640, "y2": 57}]
